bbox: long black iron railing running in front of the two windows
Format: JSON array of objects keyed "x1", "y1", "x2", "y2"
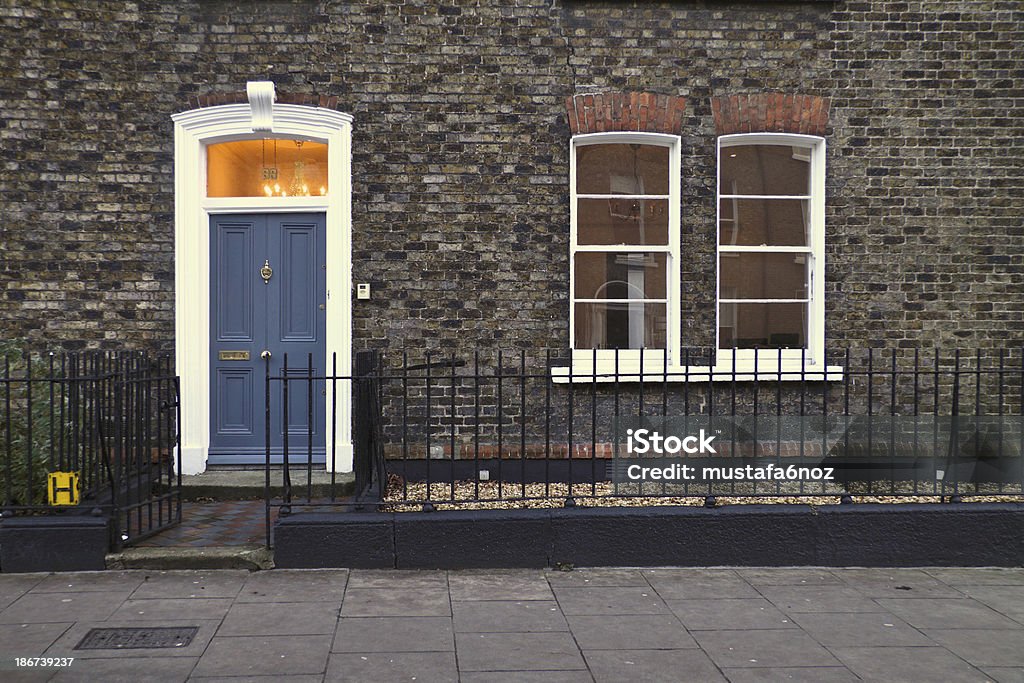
[{"x1": 267, "y1": 348, "x2": 1024, "y2": 518}]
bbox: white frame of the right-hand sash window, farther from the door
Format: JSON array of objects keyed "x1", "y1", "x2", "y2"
[{"x1": 715, "y1": 133, "x2": 839, "y2": 379}]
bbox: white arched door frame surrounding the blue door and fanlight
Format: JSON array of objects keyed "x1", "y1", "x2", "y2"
[{"x1": 171, "y1": 90, "x2": 352, "y2": 474}]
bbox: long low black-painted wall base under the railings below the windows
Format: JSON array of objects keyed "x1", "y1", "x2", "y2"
[{"x1": 274, "y1": 503, "x2": 1024, "y2": 569}]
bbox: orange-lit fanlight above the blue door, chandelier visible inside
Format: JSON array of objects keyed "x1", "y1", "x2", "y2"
[{"x1": 206, "y1": 140, "x2": 328, "y2": 197}]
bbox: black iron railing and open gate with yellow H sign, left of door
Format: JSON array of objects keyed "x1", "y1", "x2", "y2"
[{"x1": 0, "y1": 352, "x2": 181, "y2": 549}]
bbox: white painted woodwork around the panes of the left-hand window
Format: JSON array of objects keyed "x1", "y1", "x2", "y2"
[{"x1": 569, "y1": 132, "x2": 682, "y2": 370}]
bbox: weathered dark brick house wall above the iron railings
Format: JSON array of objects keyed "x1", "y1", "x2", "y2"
[{"x1": 0, "y1": 0, "x2": 1024, "y2": 358}]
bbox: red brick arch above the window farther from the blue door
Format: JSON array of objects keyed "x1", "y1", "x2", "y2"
[{"x1": 711, "y1": 92, "x2": 829, "y2": 135}]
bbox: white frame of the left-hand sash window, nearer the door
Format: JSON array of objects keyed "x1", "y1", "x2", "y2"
[{"x1": 569, "y1": 132, "x2": 681, "y2": 381}]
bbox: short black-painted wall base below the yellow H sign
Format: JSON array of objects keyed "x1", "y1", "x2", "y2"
[{"x1": 0, "y1": 515, "x2": 111, "y2": 573}]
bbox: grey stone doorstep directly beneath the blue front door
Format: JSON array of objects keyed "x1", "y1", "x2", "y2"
[{"x1": 181, "y1": 467, "x2": 355, "y2": 501}]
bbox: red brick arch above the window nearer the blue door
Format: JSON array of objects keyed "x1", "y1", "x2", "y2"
[{"x1": 565, "y1": 92, "x2": 686, "y2": 135}]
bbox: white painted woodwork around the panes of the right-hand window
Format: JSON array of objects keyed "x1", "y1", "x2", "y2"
[{"x1": 715, "y1": 133, "x2": 827, "y2": 370}]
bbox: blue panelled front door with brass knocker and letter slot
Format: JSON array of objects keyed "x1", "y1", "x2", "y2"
[{"x1": 209, "y1": 213, "x2": 327, "y2": 465}]
